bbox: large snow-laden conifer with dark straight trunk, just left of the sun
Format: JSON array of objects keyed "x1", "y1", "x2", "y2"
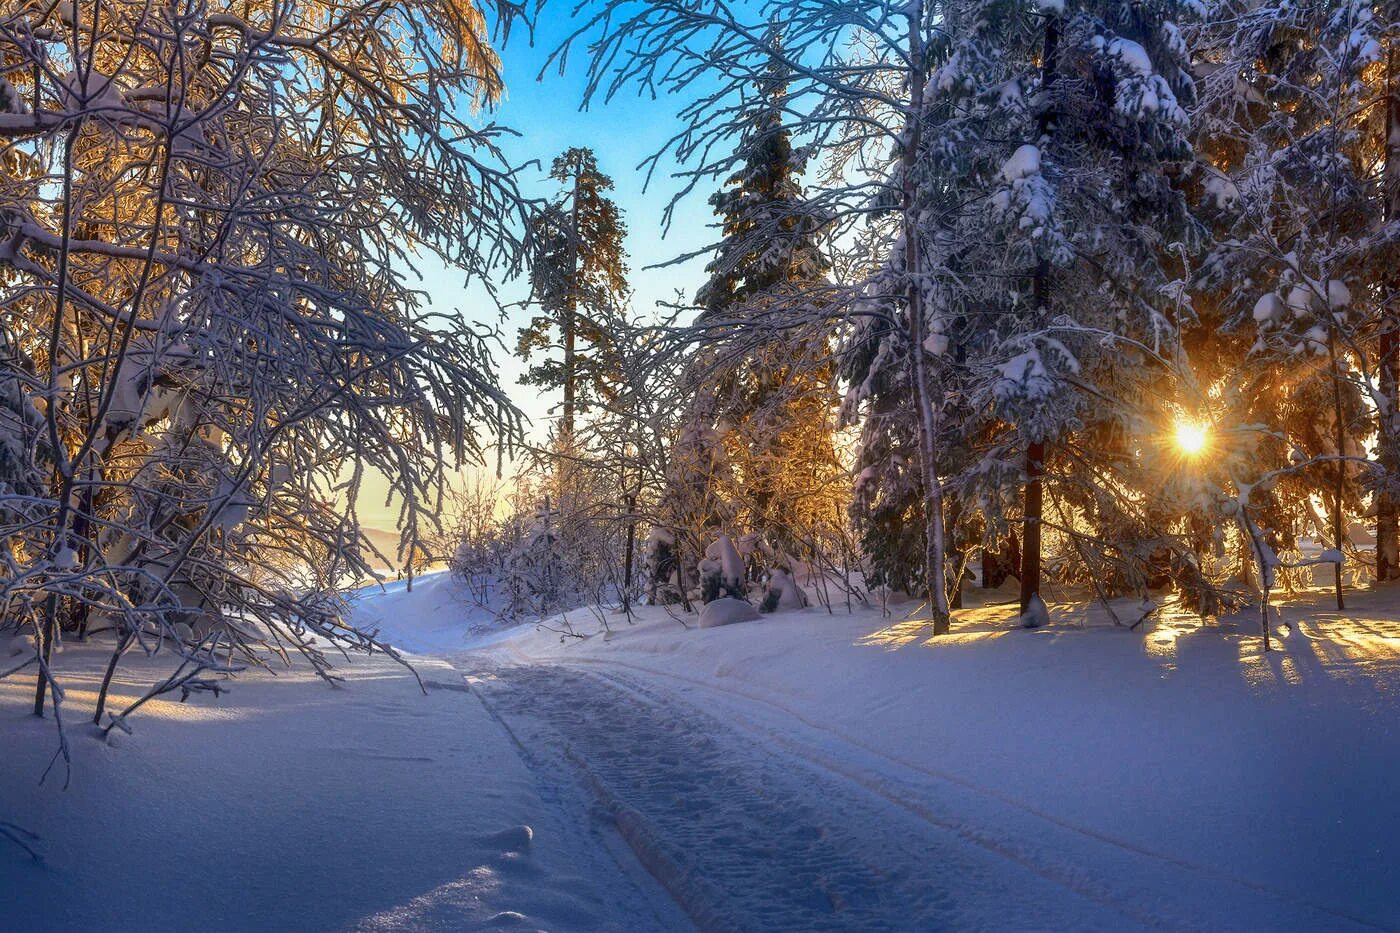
[{"x1": 912, "y1": 0, "x2": 1209, "y2": 611}]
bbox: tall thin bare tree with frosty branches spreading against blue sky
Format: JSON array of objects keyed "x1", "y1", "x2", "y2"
[{"x1": 560, "y1": 0, "x2": 974, "y2": 628}]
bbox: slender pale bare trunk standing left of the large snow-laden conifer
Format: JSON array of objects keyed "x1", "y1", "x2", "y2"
[{"x1": 900, "y1": 0, "x2": 952, "y2": 635}]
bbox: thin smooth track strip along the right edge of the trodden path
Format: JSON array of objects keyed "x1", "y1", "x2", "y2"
[{"x1": 560, "y1": 658, "x2": 1390, "y2": 930}]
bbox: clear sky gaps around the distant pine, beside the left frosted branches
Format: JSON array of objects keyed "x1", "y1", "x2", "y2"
[{"x1": 350, "y1": 7, "x2": 715, "y2": 530}]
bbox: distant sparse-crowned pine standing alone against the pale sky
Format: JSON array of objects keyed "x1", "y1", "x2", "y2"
[{"x1": 517, "y1": 148, "x2": 627, "y2": 440}]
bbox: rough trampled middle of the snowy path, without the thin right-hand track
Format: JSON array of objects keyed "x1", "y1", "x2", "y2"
[{"x1": 472, "y1": 665, "x2": 1148, "y2": 930}]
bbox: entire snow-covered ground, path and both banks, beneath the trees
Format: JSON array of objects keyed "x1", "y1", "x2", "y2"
[{"x1": 0, "y1": 576, "x2": 1400, "y2": 930}]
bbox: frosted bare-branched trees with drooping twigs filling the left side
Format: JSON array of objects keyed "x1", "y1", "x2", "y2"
[{"x1": 0, "y1": 0, "x2": 531, "y2": 745}]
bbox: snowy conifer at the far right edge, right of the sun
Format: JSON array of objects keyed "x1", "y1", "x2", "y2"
[{"x1": 1197, "y1": 3, "x2": 1400, "y2": 607}]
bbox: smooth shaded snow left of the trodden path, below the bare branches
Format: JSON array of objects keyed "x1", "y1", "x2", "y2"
[{"x1": 0, "y1": 624, "x2": 683, "y2": 932}]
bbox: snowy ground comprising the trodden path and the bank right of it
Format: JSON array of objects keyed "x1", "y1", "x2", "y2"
[{"x1": 368, "y1": 579, "x2": 1400, "y2": 929}]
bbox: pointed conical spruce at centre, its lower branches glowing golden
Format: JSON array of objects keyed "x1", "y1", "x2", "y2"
[{"x1": 669, "y1": 47, "x2": 843, "y2": 577}]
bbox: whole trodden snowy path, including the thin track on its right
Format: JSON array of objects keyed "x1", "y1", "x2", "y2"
[{"x1": 469, "y1": 664, "x2": 1366, "y2": 930}]
